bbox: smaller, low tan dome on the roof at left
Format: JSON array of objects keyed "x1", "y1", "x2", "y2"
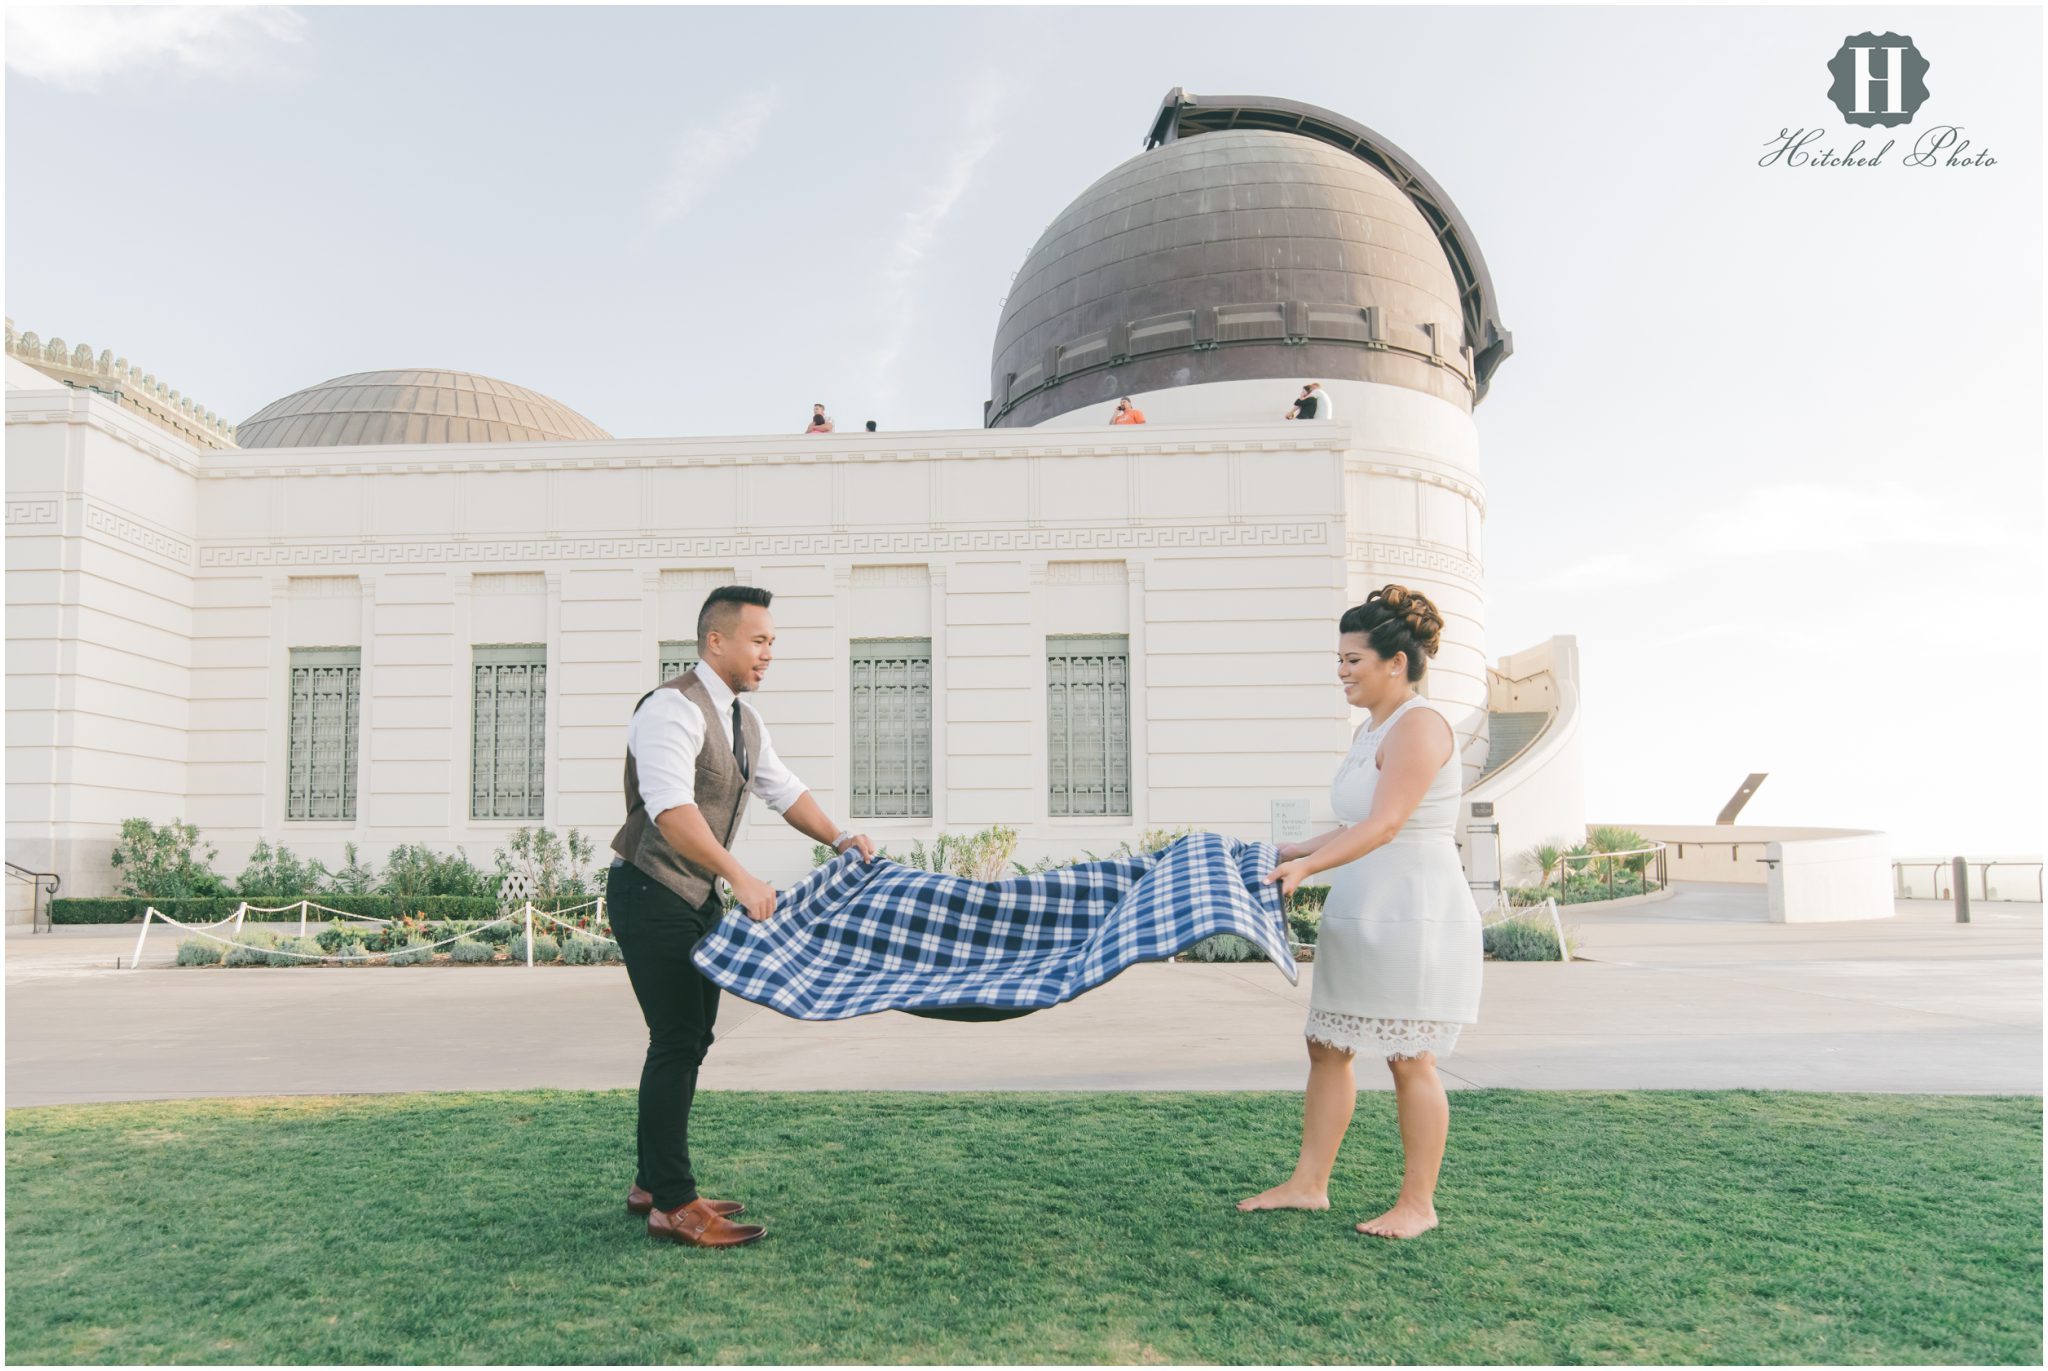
[{"x1": 236, "y1": 371, "x2": 612, "y2": 447}]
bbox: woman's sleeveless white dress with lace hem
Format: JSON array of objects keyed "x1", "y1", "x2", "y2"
[{"x1": 1307, "y1": 697, "x2": 1485, "y2": 1057}]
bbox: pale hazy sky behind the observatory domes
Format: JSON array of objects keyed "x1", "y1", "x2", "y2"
[{"x1": 6, "y1": 6, "x2": 2048, "y2": 855}]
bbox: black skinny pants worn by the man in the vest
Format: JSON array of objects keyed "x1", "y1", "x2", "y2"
[{"x1": 604, "y1": 865, "x2": 723, "y2": 1209}]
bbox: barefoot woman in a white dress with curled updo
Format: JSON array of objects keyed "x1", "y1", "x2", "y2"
[{"x1": 1237, "y1": 586, "x2": 1483, "y2": 1238}]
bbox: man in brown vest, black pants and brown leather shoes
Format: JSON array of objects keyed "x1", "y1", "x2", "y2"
[{"x1": 606, "y1": 586, "x2": 874, "y2": 1248}]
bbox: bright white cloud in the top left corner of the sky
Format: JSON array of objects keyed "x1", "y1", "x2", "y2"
[{"x1": 6, "y1": 4, "x2": 307, "y2": 92}]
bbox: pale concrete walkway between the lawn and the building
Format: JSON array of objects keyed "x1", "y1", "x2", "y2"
[{"x1": 4, "y1": 885, "x2": 2042, "y2": 1107}]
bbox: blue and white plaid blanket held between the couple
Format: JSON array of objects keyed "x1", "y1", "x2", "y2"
[{"x1": 696, "y1": 832, "x2": 1298, "y2": 1019}]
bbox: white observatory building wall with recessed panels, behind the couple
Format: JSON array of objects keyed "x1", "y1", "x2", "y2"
[{"x1": 8, "y1": 387, "x2": 1523, "y2": 894}]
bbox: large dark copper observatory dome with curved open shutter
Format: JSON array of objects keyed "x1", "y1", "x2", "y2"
[{"x1": 985, "y1": 90, "x2": 1511, "y2": 426}]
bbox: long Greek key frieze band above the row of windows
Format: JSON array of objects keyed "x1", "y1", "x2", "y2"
[{"x1": 199, "y1": 523, "x2": 1329, "y2": 570}]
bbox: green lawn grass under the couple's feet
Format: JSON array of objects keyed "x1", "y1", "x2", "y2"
[{"x1": 6, "y1": 1090, "x2": 2042, "y2": 1365}]
